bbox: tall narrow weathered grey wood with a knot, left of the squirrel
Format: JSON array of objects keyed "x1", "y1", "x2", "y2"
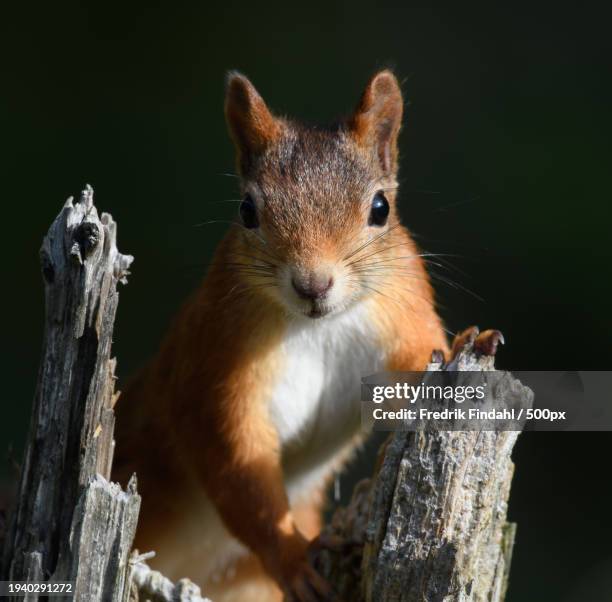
[{"x1": 1, "y1": 187, "x2": 140, "y2": 602}]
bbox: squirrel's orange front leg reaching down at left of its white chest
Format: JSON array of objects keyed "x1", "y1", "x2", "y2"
[{"x1": 185, "y1": 390, "x2": 332, "y2": 602}]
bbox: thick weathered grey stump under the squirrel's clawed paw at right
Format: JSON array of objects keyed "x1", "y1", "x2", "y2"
[{"x1": 316, "y1": 347, "x2": 533, "y2": 602}]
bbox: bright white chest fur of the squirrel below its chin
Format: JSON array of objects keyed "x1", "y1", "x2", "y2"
[{"x1": 268, "y1": 305, "x2": 384, "y2": 498}]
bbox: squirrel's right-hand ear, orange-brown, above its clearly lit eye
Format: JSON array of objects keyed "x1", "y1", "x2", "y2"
[{"x1": 348, "y1": 69, "x2": 404, "y2": 173}]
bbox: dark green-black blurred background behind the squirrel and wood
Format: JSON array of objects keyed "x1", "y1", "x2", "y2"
[{"x1": 0, "y1": 0, "x2": 612, "y2": 602}]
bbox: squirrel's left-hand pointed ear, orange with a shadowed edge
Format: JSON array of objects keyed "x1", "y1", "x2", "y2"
[{"x1": 225, "y1": 71, "x2": 281, "y2": 169}]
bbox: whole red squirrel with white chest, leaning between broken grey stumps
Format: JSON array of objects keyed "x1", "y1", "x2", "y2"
[{"x1": 114, "y1": 70, "x2": 497, "y2": 602}]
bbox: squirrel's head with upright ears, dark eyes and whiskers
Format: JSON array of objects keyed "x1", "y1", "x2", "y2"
[{"x1": 225, "y1": 70, "x2": 403, "y2": 318}]
